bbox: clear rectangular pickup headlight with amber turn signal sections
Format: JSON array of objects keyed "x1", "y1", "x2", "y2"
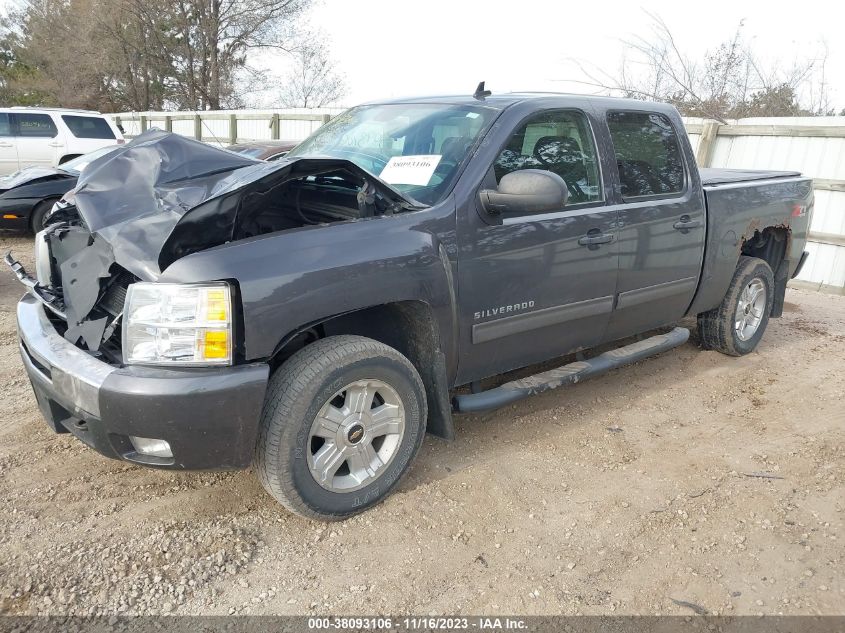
[{"x1": 123, "y1": 282, "x2": 232, "y2": 366}]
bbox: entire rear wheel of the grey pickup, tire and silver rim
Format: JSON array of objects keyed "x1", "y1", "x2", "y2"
[{"x1": 698, "y1": 256, "x2": 775, "y2": 356}]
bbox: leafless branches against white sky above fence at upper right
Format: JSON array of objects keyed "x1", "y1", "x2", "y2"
[{"x1": 575, "y1": 13, "x2": 832, "y2": 122}]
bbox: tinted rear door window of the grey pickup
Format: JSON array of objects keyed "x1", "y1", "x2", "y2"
[{"x1": 607, "y1": 112, "x2": 684, "y2": 198}]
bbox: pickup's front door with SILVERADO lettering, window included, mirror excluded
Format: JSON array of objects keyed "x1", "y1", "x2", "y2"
[{"x1": 458, "y1": 109, "x2": 619, "y2": 384}]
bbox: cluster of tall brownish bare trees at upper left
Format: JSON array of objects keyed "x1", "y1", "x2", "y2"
[{"x1": 0, "y1": 0, "x2": 311, "y2": 110}]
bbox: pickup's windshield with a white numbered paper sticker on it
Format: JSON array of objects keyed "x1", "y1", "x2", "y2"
[{"x1": 287, "y1": 103, "x2": 496, "y2": 205}]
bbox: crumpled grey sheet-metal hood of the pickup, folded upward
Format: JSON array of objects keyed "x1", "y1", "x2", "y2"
[{"x1": 15, "y1": 130, "x2": 419, "y2": 351}]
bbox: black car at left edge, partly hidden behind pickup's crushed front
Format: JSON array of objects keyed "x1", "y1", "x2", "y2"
[{"x1": 0, "y1": 145, "x2": 117, "y2": 233}]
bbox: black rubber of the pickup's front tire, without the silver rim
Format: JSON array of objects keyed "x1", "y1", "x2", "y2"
[{"x1": 254, "y1": 335, "x2": 427, "y2": 521}]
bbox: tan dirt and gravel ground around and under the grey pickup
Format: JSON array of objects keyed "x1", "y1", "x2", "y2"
[{"x1": 0, "y1": 234, "x2": 845, "y2": 615}]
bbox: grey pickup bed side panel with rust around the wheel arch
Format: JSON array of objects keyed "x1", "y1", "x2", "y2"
[{"x1": 688, "y1": 177, "x2": 813, "y2": 315}]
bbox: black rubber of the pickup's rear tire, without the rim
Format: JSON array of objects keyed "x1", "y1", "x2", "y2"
[{"x1": 698, "y1": 256, "x2": 775, "y2": 356}]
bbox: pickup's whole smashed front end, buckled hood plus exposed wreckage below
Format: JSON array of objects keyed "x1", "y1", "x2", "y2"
[{"x1": 5, "y1": 130, "x2": 422, "y2": 364}]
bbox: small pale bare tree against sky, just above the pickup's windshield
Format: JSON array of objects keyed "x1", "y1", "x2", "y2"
[{"x1": 279, "y1": 44, "x2": 349, "y2": 108}]
